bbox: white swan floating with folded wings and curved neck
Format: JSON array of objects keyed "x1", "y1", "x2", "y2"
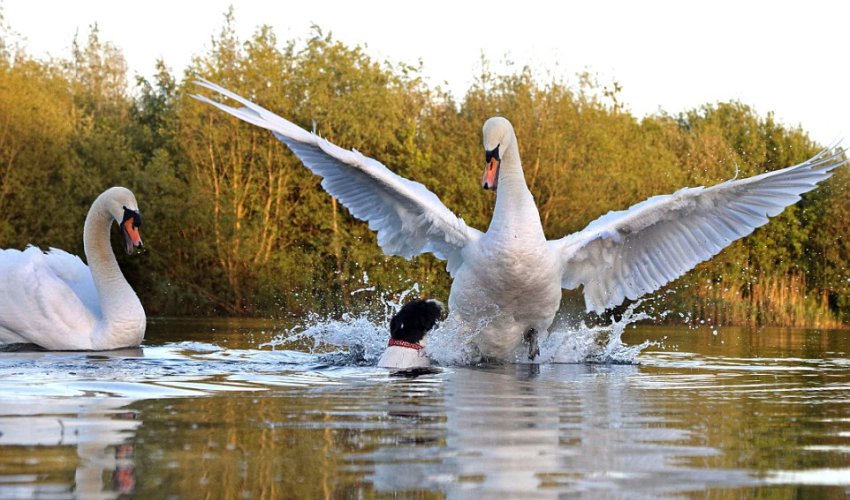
[{"x1": 0, "y1": 187, "x2": 145, "y2": 350}]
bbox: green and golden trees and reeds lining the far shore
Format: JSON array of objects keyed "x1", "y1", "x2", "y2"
[{"x1": 0, "y1": 10, "x2": 850, "y2": 326}]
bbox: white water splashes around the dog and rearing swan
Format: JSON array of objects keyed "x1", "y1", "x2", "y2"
[{"x1": 260, "y1": 285, "x2": 652, "y2": 366}]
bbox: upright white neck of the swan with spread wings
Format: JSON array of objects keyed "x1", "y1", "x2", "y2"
[{"x1": 487, "y1": 139, "x2": 545, "y2": 242}]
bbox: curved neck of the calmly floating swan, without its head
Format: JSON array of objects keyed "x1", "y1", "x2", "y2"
[{"x1": 83, "y1": 196, "x2": 144, "y2": 335}]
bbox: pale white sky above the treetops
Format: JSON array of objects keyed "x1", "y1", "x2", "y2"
[{"x1": 0, "y1": 0, "x2": 850, "y2": 146}]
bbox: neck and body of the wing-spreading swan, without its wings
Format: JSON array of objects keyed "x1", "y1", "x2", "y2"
[{"x1": 449, "y1": 129, "x2": 561, "y2": 359}]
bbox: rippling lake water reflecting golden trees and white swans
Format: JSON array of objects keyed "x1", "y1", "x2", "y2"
[{"x1": 0, "y1": 320, "x2": 850, "y2": 499}]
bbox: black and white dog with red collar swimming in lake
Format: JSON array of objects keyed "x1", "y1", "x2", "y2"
[{"x1": 378, "y1": 299, "x2": 443, "y2": 368}]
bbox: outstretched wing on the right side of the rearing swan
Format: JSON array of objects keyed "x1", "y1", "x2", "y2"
[{"x1": 549, "y1": 147, "x2": 847, "y2": 312}]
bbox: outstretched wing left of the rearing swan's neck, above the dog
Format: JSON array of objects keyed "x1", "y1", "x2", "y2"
[{"x1": 193, "y1": 79, "x2": 481, "y2": 273}]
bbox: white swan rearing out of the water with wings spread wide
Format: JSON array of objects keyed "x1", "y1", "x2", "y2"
[{"x1": 195, "y1": 80, "x2": 846, "y2": 359}]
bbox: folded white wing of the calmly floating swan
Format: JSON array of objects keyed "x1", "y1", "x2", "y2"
[{"x1": 0, "y1": 247, "x2": 97, "y2": 349}]
